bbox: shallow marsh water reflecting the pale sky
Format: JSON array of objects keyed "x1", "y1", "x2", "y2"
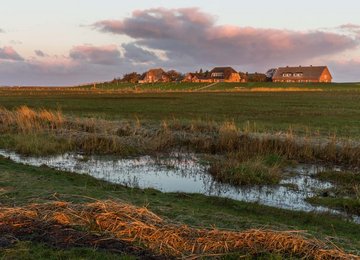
[{"x1": 0, "y1": 150, "x2": 360, "y2": 222}]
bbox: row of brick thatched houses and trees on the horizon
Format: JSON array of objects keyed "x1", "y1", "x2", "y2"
[{"x1": 114, "y1": 66, "x2": 332, "y2": 84}]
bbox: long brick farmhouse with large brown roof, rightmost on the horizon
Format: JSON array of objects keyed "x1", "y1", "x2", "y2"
[{"x1": 272, "y1": 66, "x2": 332, "y2": 83}]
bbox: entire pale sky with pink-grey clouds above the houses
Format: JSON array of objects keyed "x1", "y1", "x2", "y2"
[{"x1": 0, "y1": 0, "x2": 360, "y2": 86}]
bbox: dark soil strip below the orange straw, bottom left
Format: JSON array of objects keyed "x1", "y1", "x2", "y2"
[{"x1": 0, "y1": 215, "x2": 169, "y2": 259}]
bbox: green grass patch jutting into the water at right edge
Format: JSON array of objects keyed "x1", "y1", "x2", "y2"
[{"x1": 307, "y1": 171, "x2": 360, "y2": 215}]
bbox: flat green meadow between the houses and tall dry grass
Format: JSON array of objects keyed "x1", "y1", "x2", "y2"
[{"x1": 0, "y1": 83, "x2": 360, "y2": 138}]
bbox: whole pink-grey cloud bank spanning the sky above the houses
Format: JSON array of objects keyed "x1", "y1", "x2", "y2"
[{"x1": 0, "y1": 8, "x2": 360, "y2": 85}]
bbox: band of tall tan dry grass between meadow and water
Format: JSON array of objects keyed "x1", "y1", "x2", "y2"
[{"x1": 0, "y1": 107, "x2": 360, "y2": 169}]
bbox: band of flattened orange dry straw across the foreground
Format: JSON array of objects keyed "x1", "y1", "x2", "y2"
[{"x1": 0, "y1": 201, "x2": 358, "y2": 260}]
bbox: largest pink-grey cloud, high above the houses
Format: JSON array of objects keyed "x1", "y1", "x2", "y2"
[{"x1": 93, "y1": 8, "x2": 358, "y2": 67}]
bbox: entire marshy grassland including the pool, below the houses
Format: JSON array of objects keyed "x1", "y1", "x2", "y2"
[{"x1": 0, "y1": 83, "x2": 360, "y2": 259}]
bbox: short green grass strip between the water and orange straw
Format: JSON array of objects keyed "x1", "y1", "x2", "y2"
[{"x1": 0, "y1": 154, "x2": 360, "y2": 254}]
